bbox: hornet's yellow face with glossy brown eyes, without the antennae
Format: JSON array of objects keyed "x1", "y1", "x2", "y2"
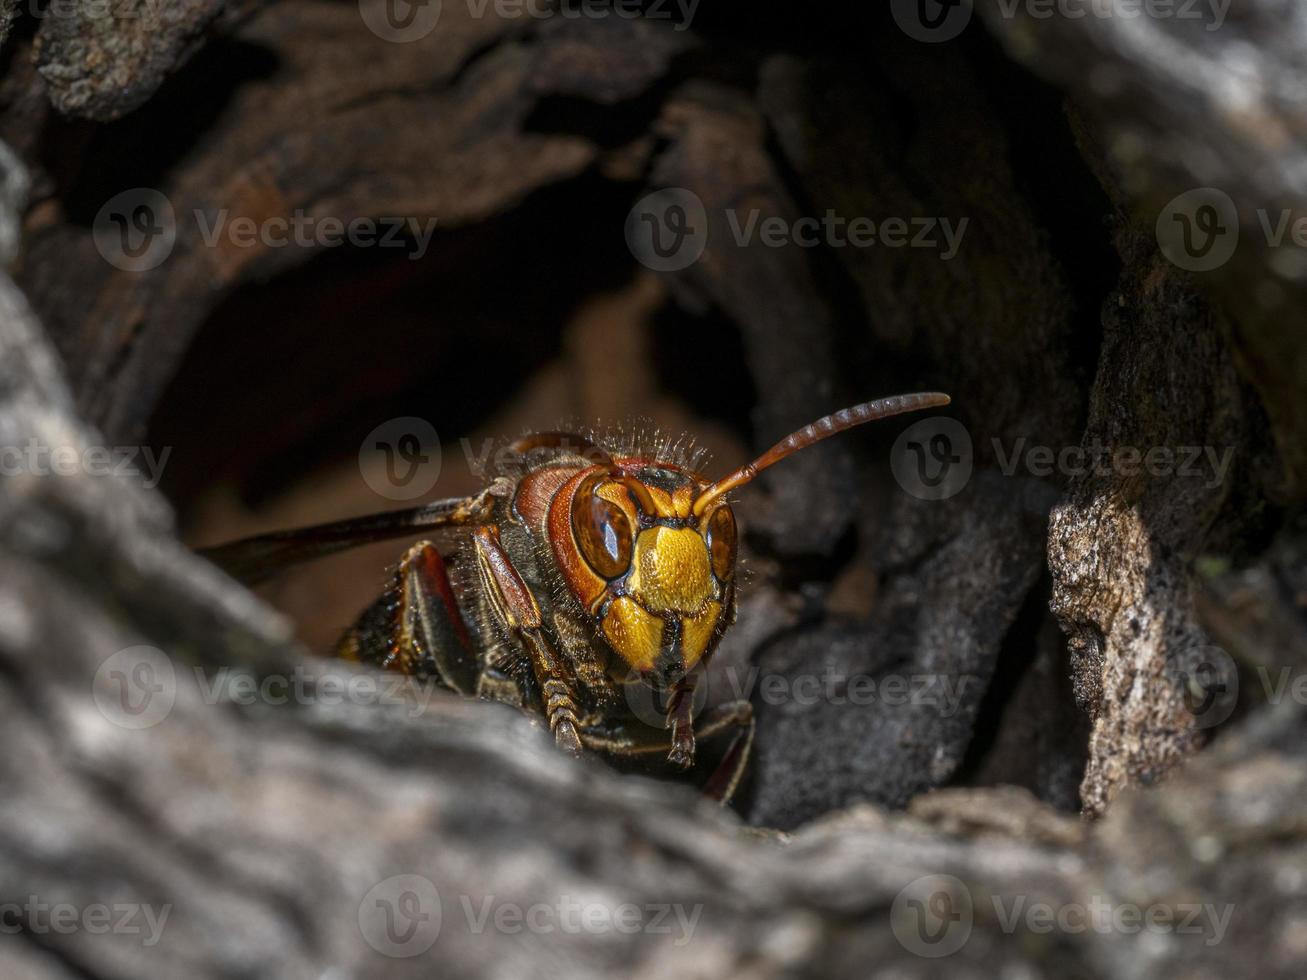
[{"x1": 553, "y1": 460, "x2": 736, "y2": 686}]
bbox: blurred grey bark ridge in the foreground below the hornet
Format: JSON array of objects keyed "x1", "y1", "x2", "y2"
[{"x1": 0, "y1": 299, "x2": 1307, "y2": 977}]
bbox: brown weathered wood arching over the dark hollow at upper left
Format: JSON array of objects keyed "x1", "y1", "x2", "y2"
[{"x1": 24, "y1": 3, "x2": 685, "y2": 440}]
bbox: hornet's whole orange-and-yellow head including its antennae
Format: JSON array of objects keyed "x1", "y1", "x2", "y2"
[{"x1": 533, "y1": 392, "x2": 949, "y2": 687}]
